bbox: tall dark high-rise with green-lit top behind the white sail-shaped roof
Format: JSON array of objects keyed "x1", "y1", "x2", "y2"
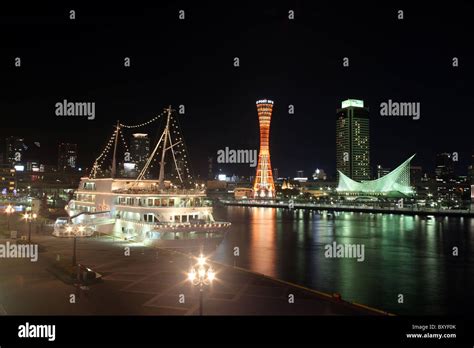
[{"x1": 336, "y1": 99, "x2": 370, "y2": 181}]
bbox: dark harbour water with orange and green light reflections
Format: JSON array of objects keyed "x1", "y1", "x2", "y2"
[{"x1": 215, "y1": 207, "x2": 474, "y2": 314}]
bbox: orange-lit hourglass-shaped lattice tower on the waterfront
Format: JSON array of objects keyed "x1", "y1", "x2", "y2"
[{"x1": 253, "y1": 99, "x2": 275, "y2": 198}]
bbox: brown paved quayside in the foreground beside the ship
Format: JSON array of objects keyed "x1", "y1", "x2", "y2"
[{"x1": 0, "y1": 228, "x2": 386, "y2": 315}]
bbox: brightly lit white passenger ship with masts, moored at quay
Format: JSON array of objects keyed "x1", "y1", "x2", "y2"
[{"x1": 54, "y1": 104, "x2": 230, "y2": 248}]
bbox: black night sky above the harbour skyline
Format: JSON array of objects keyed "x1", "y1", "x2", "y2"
[{"x1": 0, "y1": 1, "x2": 474, "y2": 176}]
